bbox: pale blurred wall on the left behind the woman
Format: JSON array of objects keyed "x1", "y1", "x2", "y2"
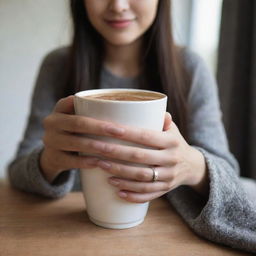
[{"x1": 0, "y1": 0, "x2": 70, "y2": 178}]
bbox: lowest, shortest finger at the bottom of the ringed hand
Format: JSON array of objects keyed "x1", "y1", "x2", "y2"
[{"x1": 117, "y1": 191, "x2": 166, "y2": 203}]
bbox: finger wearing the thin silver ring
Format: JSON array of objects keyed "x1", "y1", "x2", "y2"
[{"x1": 97, "y1": 160, "x2": 177, "y2": 182}]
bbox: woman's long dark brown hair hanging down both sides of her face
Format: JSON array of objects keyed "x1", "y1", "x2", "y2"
[{"x1": 67, "y1": 0, "x2": 189, "y2": 138}]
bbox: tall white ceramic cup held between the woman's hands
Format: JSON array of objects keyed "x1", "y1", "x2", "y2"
[{"x1": 74, "y1": 89, "x2": 167, "y2": 229}]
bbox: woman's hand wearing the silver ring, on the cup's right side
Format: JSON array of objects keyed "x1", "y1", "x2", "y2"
[{"x1": 92, "y1": 113, "x2": 208, "y2": 203}]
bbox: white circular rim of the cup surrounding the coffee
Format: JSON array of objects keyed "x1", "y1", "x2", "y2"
[{"x1": 74, "y1": 88, "x2": 167, "y2": 104}]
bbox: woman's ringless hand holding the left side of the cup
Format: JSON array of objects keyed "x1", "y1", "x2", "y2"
[{"x1": 40, "y1": 96, "x2": 125, "y2": 183}]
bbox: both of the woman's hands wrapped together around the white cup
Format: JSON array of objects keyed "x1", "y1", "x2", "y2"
[{"x1": 40, "y1": 96, "x2": 208, "y2": 202}]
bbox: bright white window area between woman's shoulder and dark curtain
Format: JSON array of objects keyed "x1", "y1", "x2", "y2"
[{"x1": 173, "y1": 0, "x2": 223, "y2": 73}]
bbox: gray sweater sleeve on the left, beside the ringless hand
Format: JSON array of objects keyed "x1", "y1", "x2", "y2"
[{"x1": 8, "y1": 48, "x2": 75, "y2": 198}]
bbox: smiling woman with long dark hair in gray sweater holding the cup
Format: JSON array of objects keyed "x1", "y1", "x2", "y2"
[{"x1": 9, "y1": 0, "x2": 256, "y2": 251}]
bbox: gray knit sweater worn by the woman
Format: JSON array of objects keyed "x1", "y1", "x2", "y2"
[{"x1": 8, "y1": 48, "x2": 256, "y2": 252}]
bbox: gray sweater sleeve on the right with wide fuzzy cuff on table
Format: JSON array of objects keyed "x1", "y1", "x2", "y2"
[{"x1": 167, "y1": 49, "x2": 256, "y2": 252}]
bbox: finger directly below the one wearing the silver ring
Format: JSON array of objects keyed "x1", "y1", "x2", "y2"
[{"x1": 109, "y1": 177, "x2": 173, "y2": 194}]
